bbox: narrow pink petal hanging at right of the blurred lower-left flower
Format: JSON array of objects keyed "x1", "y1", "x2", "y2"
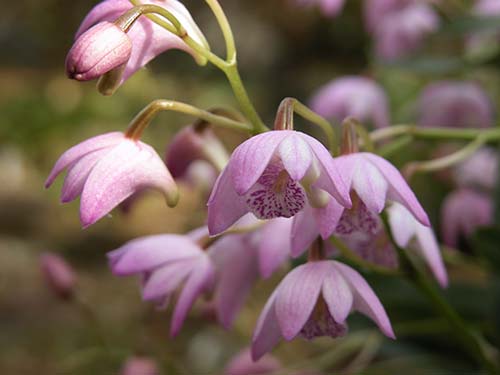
[{"x1": 170, "y1": 256, "x2": 215, "y2": 337}]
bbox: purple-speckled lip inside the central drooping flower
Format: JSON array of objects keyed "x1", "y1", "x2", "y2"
[{"x1": 245, "y1": 159, "x2": 306, "y2": 219}]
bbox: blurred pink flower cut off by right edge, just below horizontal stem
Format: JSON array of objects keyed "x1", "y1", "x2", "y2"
[{"x1": 453, "y1": 147, "x2": 498, "y2": 191}]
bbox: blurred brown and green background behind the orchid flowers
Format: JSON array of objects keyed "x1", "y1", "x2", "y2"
[{"x1": 0, "y1": 0, "x2": 500, "y2": 375}]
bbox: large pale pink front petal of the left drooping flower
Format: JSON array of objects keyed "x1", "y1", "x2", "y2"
[{"x1": 80, "y1": 140, "x2": 178, "y2": 227}]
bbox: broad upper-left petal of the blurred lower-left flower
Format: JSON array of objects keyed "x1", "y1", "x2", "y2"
[{"x1": 108, "y1": 234, "x2": 202, "y2": 276}]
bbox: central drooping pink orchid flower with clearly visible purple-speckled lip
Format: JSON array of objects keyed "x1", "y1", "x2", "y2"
[{"x1": 208, "y1": 130, "x2": 351, "y2": 235}]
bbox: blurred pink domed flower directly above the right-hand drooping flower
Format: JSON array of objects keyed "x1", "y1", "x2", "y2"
[{"x1": 311, "y1": 76, "x2": 389, "y2": 128}]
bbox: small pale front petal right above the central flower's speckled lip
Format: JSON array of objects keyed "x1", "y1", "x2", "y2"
[{"x1": 278, "y1": 133, "x2": 312, "y2": 181}]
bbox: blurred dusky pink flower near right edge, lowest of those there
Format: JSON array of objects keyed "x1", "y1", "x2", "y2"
[{"x1": 441, "y1": 189, "x2": 493, "y2": 248}]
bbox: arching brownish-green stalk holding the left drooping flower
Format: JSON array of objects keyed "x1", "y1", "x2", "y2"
[{"x1": 126, "y1": 99, "x2": 251, "y2": 139}]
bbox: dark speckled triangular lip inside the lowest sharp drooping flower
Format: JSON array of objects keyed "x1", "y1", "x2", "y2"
[{"x1": 300, "y1": 296, "x2": 347, "y2": 340}]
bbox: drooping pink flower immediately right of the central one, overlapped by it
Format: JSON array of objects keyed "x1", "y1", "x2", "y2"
[{"x1": 292, "y1": 152, "x2": 430, "y2": 256}]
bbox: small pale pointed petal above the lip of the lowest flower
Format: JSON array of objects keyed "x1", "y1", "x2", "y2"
[{"x1": 321, "y1": 262, "x2": 354, "y2": 324}]
